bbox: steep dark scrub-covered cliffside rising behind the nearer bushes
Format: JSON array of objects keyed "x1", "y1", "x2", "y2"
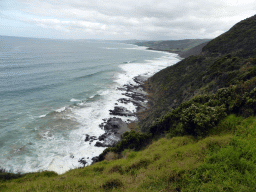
[{"x1": 140, "y1": 15, "x2": 256, "y2": 132}]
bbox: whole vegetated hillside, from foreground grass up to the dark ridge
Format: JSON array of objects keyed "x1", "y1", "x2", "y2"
[{"x1": 0, "y1": 15, "x2": 256, "y2": 191}]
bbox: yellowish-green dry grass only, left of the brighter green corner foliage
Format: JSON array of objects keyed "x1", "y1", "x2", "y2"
[{"x1": 0, "y1": 130, "x2": 232, "y2": 191}]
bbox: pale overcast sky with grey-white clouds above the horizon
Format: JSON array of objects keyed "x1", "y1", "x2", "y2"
[{"x1": 0, "y1": 0, "x2": 256, "y2": 40}]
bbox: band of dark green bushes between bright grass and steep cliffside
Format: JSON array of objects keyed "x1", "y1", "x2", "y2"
[{"x1": 147, "y1": 78, "x2": 256, "y2": 137}]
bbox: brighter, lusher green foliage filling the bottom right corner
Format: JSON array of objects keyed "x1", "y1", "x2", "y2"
[{"x1": 181, "y1": 116, "x2": 256, "y2": 191}]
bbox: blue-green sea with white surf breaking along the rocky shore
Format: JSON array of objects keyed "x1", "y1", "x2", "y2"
[{"x1": 0, "y1": 36, "x2": 179, "y2": 174}]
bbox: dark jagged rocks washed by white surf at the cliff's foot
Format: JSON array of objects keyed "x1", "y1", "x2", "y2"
[{"x1": 78, "y1": 76, "x2": 148, "y2": 166}]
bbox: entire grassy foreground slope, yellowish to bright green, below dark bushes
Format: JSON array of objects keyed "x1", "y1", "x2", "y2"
[{"x1": 0, "y1": 115, "x2": 256, "y2": 191}]
